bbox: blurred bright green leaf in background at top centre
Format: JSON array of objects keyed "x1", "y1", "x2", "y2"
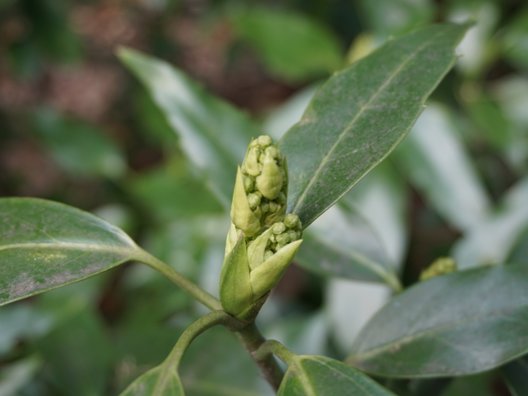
[{"x1": 231, "y1": 7, "x2": 342, "y2": 81}]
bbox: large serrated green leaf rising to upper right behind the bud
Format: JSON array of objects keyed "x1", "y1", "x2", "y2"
[{"x1": 281, "y1": 25, "x2": 466, "y2": 227}]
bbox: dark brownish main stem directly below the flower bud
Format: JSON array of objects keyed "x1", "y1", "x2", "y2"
[{"x1": 237, "y1": 323, "x2": 284, "y2": 391}]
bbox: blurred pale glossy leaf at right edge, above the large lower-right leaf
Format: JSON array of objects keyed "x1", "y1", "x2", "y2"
[{"x1": 452, "y1": 179, "x2": 528, "y2": 268}]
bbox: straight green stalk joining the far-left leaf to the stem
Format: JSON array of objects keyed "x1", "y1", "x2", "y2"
[{"x1": 135, "y1": 250, "x2": 222, "y2": 311}]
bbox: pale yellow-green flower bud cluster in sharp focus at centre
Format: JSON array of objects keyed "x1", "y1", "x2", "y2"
[{"x1": 220, "y1": 135, "x2": 302, "y2": 319}]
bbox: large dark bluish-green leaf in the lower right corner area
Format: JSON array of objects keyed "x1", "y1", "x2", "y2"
[{"x1": 348, "y1": 265, "x2": 528, "y2": 377}]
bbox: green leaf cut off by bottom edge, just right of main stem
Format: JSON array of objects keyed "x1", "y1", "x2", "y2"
[{"x1": 277, "y1": 355, "x2": 394, "y2": 396}]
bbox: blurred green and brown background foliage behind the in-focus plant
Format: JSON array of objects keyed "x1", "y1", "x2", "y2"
[{"x1": 0, "y1": 0, "x2": 528, "y2": 396}]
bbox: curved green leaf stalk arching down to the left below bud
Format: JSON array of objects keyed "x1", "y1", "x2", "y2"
[{"x1": 163, "y1": 311, "x2": 244, "y2": 370}]
